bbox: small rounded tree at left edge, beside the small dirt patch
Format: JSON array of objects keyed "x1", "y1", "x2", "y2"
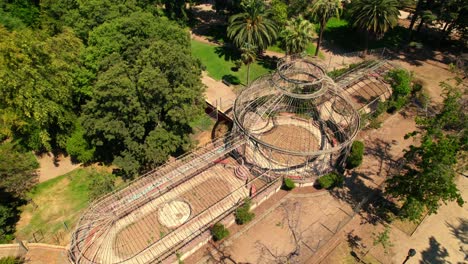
[{"x1": 0, "y1": 142, "x2": 39, "y2": 197}]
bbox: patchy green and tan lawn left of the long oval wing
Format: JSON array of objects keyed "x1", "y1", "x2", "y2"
[{"x1": 16, "y1": 168, "x2": 117, "y2": 245}]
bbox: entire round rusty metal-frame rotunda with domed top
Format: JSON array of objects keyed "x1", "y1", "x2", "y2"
[{"x1": 233, "y1": 57, "x2": 360, "y2": 182}]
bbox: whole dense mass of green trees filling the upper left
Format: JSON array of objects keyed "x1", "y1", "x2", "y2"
[{"x1": 0, "y1": 0, "x2": 204, "y2": 176}]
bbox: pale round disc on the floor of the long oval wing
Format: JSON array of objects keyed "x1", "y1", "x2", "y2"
[{"x1": 158, "y1": 200, "x2": 191, "y2": 228}]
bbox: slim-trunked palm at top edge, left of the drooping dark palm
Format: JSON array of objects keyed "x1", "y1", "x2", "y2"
[{"x1": 311, "y1": 0, "x2": 341, "y2": 56}]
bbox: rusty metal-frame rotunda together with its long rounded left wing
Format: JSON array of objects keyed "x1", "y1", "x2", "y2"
[{"x1": 69, "y1": 55, "x2": 359, "y2": 263}]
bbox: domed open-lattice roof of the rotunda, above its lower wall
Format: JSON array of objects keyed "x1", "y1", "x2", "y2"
[{"x1": 234, "y1": 58, "x2": 360, "y2": 156}]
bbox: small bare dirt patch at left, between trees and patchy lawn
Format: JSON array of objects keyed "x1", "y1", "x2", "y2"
[{"x1": 36, "y1": 153, "x2": 81, "y2": 182}]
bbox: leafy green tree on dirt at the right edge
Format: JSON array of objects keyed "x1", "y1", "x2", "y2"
[{"x1": 386, "y1": 80, "x2": 468, "y2": 221}]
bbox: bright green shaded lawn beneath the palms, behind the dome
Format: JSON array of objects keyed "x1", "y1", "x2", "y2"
[{"x1": 192, "y1": 40, "x2": 276, "y2": 85}]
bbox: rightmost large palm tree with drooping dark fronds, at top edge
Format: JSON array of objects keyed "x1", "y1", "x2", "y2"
[{"x1": 351, "y1": 0, "x2": 400, "y2": 55}]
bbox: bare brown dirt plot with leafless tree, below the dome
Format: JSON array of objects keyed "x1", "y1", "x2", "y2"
[{"x1": 227, "y1": 191, "x2": 352, "y2": 263}]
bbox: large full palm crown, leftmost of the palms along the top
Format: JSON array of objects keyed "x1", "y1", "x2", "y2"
[{"x1": 227, "y1": 0, "x2": 277, "y2": 50}]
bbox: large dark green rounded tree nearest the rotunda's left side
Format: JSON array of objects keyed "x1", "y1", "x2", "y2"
[{"x1": 82, "y1": 13, "x2": 204, "y2": 176}]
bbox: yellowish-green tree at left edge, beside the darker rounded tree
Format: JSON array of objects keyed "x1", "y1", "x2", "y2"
[{"x1": 0, "y1": 28, "x2": 82, "y2": 150}]
